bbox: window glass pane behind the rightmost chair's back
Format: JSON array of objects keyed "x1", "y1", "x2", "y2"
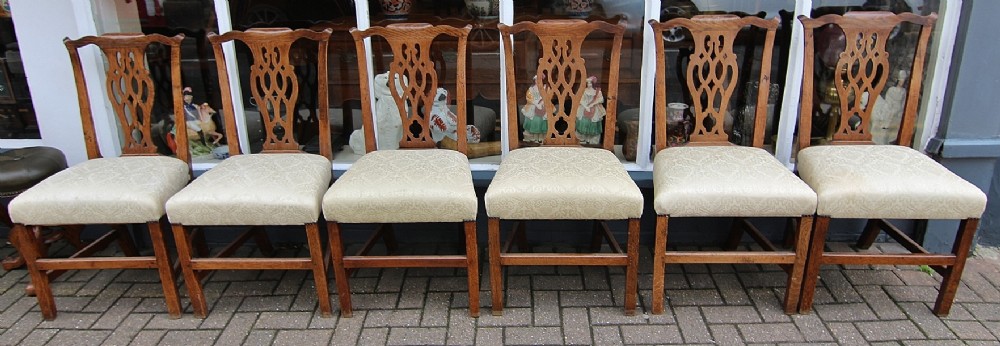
[{"x1": 811, "y1": 0, "x2": 940, "y2": 144}]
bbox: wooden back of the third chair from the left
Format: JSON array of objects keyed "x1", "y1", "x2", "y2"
[{"x1": 351, "y1": 23, "x2": 472, "y2": 154}]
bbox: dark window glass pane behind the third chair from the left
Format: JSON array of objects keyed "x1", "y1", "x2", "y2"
[{"x1": 366, "y1": 0, "x2": 502, "y2": 164}]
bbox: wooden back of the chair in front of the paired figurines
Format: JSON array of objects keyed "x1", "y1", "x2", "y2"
[{"x1": 497, "y1": 19, "x2": 625, "y2": 151}]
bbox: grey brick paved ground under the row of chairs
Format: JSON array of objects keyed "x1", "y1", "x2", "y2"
[{"x1": 0, "y1": 239, "x2": 1000, "y2": 346}]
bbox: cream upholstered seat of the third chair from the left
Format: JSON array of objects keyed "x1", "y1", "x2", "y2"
[{"x1": 323, "y1": 149, "x2": 479, "y2": 223}]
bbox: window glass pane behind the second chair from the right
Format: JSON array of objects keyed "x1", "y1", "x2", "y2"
[{"x1": 659, "y1": 0, "x2": 795, "y2": 155}]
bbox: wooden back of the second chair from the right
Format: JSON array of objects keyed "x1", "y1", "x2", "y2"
[{"x1": 649, "y1": 15, "x2": 780, "y2": 152}]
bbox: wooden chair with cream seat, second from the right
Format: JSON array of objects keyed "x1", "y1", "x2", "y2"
[{"x1": 649, "y1": 15, "x2": 816, "y2": 314}]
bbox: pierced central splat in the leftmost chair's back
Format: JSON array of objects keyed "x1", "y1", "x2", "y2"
[{"x1": 104, "y1": 47, "x2": 156, "y2": 154}]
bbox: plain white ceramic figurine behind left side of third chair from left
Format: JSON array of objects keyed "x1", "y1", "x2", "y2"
[{"x1": 349, "y1": 72, "x2": 408, "y2": 155}]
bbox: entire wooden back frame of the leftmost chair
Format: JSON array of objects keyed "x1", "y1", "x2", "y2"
[{"x1": 63, "y1": 33, "x2": 191, "y2": 166}]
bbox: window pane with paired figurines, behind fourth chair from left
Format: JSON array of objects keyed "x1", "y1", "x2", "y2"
[{"x1": 511, "y1": 0, "x2": 645, "y2": 161}]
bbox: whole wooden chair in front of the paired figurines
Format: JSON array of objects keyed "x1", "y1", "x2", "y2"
[{"x1": 485, "y1": 20, "x2": 643, "y2": 315}]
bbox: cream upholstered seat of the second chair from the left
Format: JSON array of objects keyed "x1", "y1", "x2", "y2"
[{"x1": 167, "y1": 154, "x2": 332, "y2": 226}]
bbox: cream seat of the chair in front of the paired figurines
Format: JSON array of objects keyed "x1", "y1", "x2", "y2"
[{"x1": 485, "y1": 147, "x2": 642, "y2": 220}]
